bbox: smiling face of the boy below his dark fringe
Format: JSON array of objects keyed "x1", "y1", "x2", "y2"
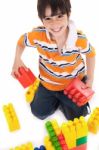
[{"x1": 42, "y1": 7, "x2": 68, "y2": 38}]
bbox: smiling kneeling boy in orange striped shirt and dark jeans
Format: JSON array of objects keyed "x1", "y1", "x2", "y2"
[{"x1": 12, "y1": 0, "x2": 95, "y2": 120}]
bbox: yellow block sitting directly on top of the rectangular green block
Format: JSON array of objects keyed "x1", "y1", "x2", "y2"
[{"x1": 73, "y1": 116, "x2": 88, "y2": 139}]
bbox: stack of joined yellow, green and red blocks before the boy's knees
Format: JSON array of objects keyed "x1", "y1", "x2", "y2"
[{"x1": 44, "y1": 117, "x2": 88, "y2": 150}]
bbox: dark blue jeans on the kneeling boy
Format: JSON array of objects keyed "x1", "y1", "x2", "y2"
[{"x1": 30, "y1": 76, "x2": 89, "y2": 120}]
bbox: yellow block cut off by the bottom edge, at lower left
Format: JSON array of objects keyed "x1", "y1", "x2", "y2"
[{"x1": 10, "y1": 142, "x2": 34, "y2": 150}]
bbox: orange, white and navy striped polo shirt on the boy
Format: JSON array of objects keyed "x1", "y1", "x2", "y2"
[{"x1": 18, "y1": 21, "x2": 95, "y2": 91}]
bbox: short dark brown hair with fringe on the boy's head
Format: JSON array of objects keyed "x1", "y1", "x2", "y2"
[{"x1": 37, "y1": 0, "x2": 71, "y2": 20}]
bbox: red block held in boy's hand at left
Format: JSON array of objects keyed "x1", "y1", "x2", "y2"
[{"x1": 15, "y1": 67, "x2": 36, "y2": 88}]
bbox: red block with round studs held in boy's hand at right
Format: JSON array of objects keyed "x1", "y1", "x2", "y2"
[{"x1": 64, "y1": 78, "x2": 94, "y2": 106}]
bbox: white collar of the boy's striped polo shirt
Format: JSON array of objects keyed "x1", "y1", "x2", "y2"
[{"x1": 46, "y1": 20, "x2": 77, "y2": 53}]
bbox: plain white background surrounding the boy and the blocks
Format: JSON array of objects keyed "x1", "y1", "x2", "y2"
[{"x1": 0, "y1": 0, "x2": 99, "y2": 150}]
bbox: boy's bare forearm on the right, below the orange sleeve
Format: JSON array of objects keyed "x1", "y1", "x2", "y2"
[{"x1": 86, "y1": 56, "x2": 95, "y2": 88}]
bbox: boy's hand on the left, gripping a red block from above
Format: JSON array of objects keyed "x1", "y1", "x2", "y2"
[{"x1": 11, "y1": 59, "x2": 28, "y2": 79}]
